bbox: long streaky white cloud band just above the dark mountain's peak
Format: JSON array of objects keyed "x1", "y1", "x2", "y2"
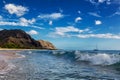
[{"x1": 0, "y1": 17, "x2": 45, "y2": 29}]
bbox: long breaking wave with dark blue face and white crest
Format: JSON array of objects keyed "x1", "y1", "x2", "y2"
[{"x1": 53, "y1": 51, "x2": 120, "y2": 65}]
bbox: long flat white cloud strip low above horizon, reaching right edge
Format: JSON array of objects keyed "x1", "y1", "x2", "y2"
[{"x1": 75, "y1": 33, "x2": 120, "y2": 39}]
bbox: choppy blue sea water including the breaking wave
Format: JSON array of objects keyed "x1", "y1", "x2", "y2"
[{"x1": 0, "y1": 50, "x2": 120, "y2": 80}]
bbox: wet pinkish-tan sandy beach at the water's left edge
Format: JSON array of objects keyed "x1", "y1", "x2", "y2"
[{"x1": 0, "y1": 49, "x2": 24, "y2": 74}]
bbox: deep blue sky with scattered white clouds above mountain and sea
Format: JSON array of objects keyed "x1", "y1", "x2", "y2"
[{"x1": 0, "y1": 0, "x2": 120, "y2": 50}]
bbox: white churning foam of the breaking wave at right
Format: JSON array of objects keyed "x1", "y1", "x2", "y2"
[{"x1": 75, "y1": 52, "x2": 120, "y2": 65}]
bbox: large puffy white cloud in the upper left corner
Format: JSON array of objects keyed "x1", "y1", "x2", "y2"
[{"x1": 5, "y1": 4, "x2": 28, "y2": 16}]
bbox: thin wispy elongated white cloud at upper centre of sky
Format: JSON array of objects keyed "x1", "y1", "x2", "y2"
[{"x1": 38, "y1": 13, "x2": 64, "y2": 20}]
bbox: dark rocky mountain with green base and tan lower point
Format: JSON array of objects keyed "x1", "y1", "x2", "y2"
[{"x1": 0, "y1": 29, "x2": 56, "y2": 49}]
